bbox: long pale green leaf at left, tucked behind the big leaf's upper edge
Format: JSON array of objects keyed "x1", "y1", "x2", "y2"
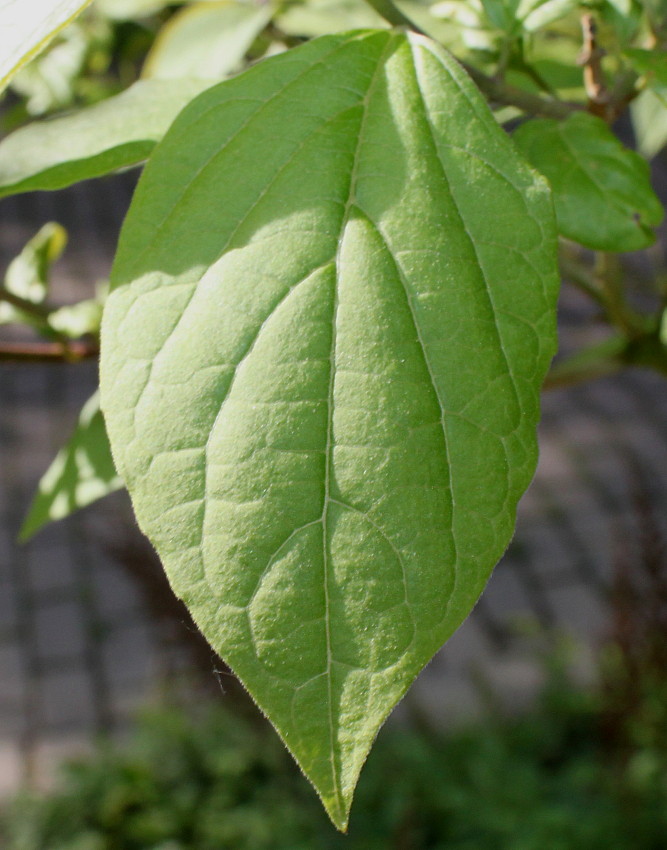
[{"x1": 0, "y1": 80, "x2": 211, "y2": 197}]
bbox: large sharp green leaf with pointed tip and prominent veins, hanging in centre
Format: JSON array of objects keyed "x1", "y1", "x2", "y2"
[{"x1": 101, "y1": 31, "x2": 557, "y2": 828}]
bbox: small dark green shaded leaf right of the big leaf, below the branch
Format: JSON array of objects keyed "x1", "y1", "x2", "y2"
[{"x1": 514, "y1": 112, "x2": 663, "y2": 251}]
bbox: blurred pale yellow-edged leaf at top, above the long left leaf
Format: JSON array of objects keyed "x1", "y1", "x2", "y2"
[{"x1": 143, "y1": 0, "x2": 273, "y2": 80}]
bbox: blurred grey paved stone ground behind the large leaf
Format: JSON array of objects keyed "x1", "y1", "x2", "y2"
[{"x1": 0, "y1": 171, "x2": 667, "y2": 793}]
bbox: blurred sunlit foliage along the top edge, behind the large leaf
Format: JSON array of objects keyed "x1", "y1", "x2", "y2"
[{"x1": 3, "y1": 0, "x2": 667, "y2": 156}]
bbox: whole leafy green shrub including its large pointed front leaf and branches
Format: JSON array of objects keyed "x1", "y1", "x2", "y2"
[{"x1": 0, "y1": 0, "x2": 667, "y2": 828}]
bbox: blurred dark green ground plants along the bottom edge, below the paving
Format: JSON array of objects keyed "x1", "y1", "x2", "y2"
[{"x1": 0, "y1": 674, "x2": 667, "y2": 850}]
